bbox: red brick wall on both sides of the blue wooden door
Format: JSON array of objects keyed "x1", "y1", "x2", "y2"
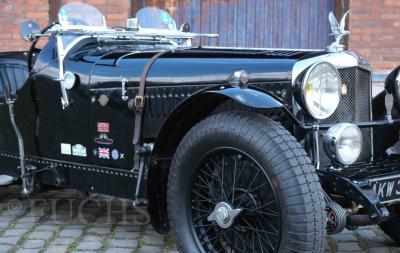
[{"x1": 0, "y1": 0, "x2": 400, "y2": 70}]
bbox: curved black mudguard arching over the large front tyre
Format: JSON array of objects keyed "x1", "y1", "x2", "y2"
[{"x1": 147, "y1": 85, "x2": 286, "y2": 233}]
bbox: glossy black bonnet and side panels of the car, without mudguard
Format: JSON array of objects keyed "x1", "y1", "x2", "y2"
[{"x1": 21, "y1": 39, "x2": 316, "y2": 169}]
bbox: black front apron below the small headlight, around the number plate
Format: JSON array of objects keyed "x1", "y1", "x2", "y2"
[{"x1": 318, "y1": 156, "x2": 400, "y2": 228}]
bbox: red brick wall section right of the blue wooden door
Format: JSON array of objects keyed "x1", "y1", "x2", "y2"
[{"x1": 349, "y1": 0, "x2": 400, "y2": 70}]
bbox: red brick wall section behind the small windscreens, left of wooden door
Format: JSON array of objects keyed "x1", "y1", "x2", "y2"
[{"x1": 0, "y1": 0, "x2": 130, "y2": 52}]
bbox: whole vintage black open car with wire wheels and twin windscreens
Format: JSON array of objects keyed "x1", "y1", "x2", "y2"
[{"x1": 0, "y1": 3, "x2": 400, "y2": 253}]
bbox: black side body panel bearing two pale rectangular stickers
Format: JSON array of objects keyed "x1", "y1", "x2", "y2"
[{"x1": 34, "y1": 53, "x2": 92, "y2": 163}]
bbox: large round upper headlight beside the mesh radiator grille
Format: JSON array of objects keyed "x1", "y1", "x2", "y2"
[{"x1": 302, "y1": 62, "x2": 342, "y2": 119}]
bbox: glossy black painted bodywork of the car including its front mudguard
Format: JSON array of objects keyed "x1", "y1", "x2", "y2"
[{"x1": 0, "y1": 35, "x2": 396, "y2": 231}]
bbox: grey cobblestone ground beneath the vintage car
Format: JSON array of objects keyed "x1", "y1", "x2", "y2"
[{"x1": 0, "y1": 186, "x2": 400, "y2": 253}]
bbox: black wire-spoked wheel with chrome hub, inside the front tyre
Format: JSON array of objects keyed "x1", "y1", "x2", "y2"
[{"x1": 189, "y1": 148, "x2": 282, "y2": 253}]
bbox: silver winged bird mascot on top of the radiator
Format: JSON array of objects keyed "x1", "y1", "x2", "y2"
[{"x1": 328, "y1": 11, "x2": 350, "y2": 52}]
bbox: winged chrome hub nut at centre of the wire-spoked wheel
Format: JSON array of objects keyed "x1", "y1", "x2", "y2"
[{"x1": 207, "y1": 202, "x2": 242, "y2": 228}]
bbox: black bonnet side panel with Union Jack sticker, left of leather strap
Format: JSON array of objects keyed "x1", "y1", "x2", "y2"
[{"x1": 89, "y1": 52, "x2": 138, "y2": 169}]
